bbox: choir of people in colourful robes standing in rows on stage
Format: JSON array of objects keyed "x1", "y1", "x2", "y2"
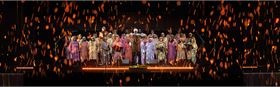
[{"x1": 65, "y1": 27, "x2": 198, "y2": 65}]
